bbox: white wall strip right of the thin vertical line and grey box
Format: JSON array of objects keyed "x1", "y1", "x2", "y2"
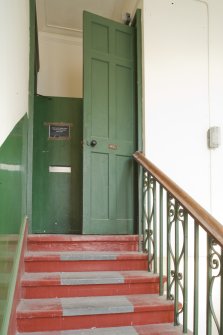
[{"x1": 208, "y1": 0, "x2": 223, "y2": 223}]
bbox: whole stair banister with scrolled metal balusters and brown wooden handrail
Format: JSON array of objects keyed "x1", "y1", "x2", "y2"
[{"x1": 133, "y1": 152, "x2": 223, "y2": 335}]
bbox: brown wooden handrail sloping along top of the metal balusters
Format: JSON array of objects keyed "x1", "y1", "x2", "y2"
[{"x1": 133, "y1": 152, "x2": 223, "y2": 248}]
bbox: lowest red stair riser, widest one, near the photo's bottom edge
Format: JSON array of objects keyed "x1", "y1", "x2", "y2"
[{"x1": 18, "y1": 310, "x2": 174, "y2": 332}]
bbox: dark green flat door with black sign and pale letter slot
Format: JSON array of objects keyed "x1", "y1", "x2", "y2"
[{"x1": 32, "y1": 96, "x2": 83, "y2": 234}]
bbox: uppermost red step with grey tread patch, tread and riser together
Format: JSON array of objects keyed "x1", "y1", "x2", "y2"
[{"x1": 25, "y1": 251, "x2": 147, "y2": 272}]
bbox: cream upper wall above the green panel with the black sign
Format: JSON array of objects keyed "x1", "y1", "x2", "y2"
[{"x1": 37, "y1": 32, "x2": 83, "y2": 98}]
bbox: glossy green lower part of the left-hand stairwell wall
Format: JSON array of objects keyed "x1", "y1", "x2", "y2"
[{"x1": 0, "y1": 115, "x2": 28, "y2": 334}]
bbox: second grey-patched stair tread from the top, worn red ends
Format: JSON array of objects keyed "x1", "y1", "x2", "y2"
[{"x1": 22, "y1": 271, "x2": 159, "y2": 286}]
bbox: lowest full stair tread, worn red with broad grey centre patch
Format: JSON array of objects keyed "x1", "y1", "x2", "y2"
[{"x1": 17, "y1": 294, "x2": 173, "y2": 318}]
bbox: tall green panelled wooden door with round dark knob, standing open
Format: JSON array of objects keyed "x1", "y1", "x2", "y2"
[{"x1": 83, "y1": 12, "x2": 136, "y2": 234}]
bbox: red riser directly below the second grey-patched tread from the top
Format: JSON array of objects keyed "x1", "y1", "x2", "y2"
[{"x1": 22, "y1": 283, "x2": 159, "y2": 299}]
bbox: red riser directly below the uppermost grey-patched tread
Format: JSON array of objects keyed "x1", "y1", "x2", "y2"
[{"x1": 25, "y1": 259, "x2": 148, "y2": 273}]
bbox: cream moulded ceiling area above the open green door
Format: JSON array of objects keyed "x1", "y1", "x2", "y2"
[{"x1": 36, "y1": 0, "x2": 138, "y2": 37}]
